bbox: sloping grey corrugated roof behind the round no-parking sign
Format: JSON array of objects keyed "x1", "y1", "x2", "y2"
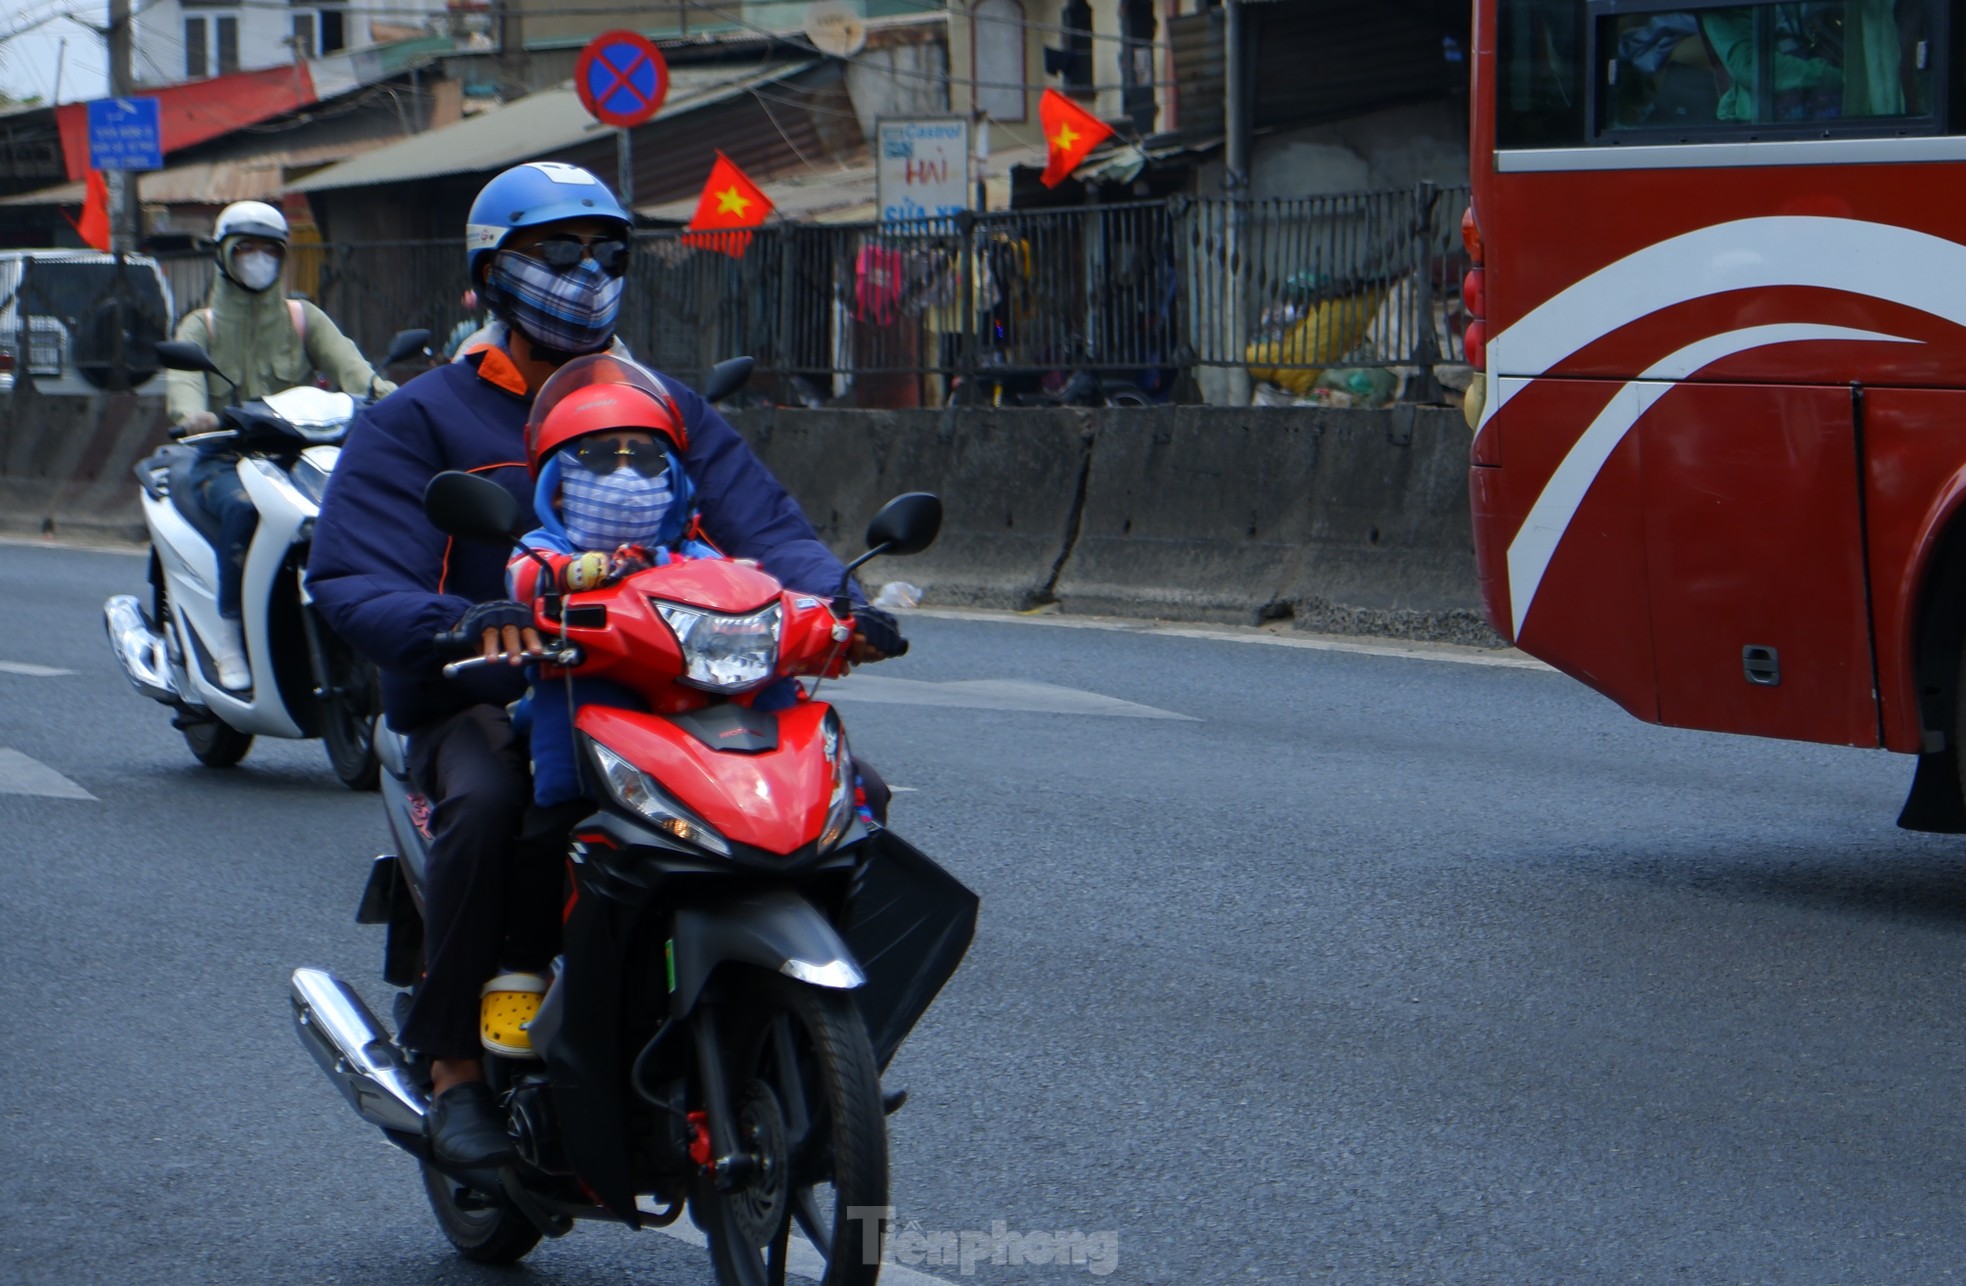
[{"x1": 287, "y1": 59, "x2": 820, "y2": 193}]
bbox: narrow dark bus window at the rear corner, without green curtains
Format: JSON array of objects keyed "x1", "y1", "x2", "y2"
[{"x1": 1494, "y1": 0, "x2": 1589, "y2": 147}]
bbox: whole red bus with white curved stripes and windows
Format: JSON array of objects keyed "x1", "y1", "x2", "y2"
[{"x1": 1465, "y1": 0, "x2": 1966, "y2": 830}]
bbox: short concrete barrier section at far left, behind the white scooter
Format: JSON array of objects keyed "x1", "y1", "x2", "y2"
[{"x1": 0, "y1": 383, "x2": 169, "y2": 541}]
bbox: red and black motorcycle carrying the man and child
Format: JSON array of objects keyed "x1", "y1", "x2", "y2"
[{"x1": 293, "y1": 474, "x2": 977, "y2": 1286}]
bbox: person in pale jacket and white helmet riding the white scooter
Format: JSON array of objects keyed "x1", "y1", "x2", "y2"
[{"x1": 165, "y1": 201, "x2": 395, "y2": 690}]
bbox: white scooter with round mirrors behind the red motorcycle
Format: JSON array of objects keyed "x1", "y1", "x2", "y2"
[{"x1": 102, "y1": 330, "x2": 431, "y2": 790}]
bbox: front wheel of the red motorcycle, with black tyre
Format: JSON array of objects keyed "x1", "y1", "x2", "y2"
[{"x1": 690, "y1": 973, "x2": 887, "y2": 1286}]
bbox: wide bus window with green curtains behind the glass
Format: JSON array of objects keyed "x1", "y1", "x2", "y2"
[{"x1": 1592, "y1": 0, "x2": 1937, "y2": 142}]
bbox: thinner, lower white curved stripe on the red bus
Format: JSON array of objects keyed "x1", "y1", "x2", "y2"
[{"x1": 1508, "y1": 322, "x2": 1913, "y2": 639}]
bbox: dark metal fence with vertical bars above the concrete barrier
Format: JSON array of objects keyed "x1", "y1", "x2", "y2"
[{"x1": 157, "y1": 185, "x2": 1467, "y2": 405}]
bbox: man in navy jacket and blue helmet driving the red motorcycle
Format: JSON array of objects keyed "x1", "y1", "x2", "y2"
[{"x1": 309, "y1": 161, "x2": 900, "y2": 1166}]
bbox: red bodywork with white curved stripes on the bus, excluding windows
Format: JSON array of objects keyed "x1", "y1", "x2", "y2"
[{"x1": 1469, "y1": 0, "x2": 1966, "y2": 751}]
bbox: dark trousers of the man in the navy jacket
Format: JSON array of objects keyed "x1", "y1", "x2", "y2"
[{"x1": 401, "y1": 706, "x2": 576, "y2": 1058}]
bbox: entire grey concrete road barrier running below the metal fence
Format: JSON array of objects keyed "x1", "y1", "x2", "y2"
[{"x1": 0, "y1": 387, "x2": 1494, "y2": 643}]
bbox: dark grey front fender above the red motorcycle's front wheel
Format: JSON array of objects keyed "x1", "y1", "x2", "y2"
[{"x1": 666, "y1": 889, "x2": 867, "y2": 1019}]
